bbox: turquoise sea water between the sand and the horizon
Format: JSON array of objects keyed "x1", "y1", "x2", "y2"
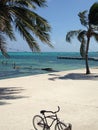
[{"x1": 0, "y1": 52, "x2": 98, "y2": 79}]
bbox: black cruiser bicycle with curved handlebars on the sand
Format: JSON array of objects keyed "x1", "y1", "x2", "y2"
[{"x1": 32, "y1": 106, "x2": 72, "y2": 130}]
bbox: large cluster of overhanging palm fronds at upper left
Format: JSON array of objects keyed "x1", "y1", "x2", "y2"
[{"x1": 0, "y1": 0, "x2": 52, "y2": 54}]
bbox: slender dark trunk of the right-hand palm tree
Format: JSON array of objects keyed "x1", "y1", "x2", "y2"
[{"x1": 85, "y1": 36, "x2": 90, "y2": 74}]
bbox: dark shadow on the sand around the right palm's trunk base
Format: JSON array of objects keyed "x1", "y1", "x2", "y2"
[{"x1": 49, "y1": 73, "x2": 98, "y2": 81}]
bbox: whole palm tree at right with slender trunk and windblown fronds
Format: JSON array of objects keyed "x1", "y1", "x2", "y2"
[{"x1": 66, "y1": 3, "x2": 98, "y2": 74}]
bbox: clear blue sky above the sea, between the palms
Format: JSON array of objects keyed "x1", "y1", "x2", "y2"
[{"x1": 8, "y1": 0, "x2": 98, "y2": 52}]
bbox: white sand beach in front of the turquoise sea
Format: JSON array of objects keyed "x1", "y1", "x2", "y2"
[{"x1": 0, "y1": 68, "x2": 98, "y2": 130}]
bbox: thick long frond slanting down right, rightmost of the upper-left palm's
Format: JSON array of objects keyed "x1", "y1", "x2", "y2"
[{"x1": 11, "y1": 7, "x2": 53, "y2": 47}]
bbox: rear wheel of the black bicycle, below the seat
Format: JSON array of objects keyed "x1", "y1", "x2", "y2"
[{"x1": 32, "y1": 115, "x2": 45, "y2": 130}]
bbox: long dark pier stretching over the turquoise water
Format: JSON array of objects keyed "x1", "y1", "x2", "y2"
[{"x1": 57, "y1": 56, "x2": 98, "y2": 61}]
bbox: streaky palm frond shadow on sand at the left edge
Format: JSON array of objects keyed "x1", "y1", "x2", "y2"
[{"x1": 0, "y1": 87, "x2": 24, "y2": 105}]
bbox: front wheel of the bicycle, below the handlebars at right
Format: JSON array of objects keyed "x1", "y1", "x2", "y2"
[{"x1": 55, "y1": 122, "x2": 71, "y2": 130}]
